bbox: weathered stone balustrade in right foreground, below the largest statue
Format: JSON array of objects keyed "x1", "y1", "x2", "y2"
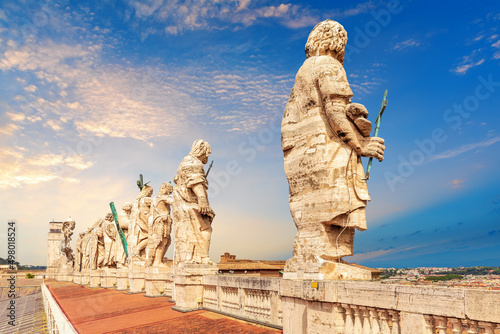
[{"x1": 280, "y1": 280, "x2": 500, "y2": 334}]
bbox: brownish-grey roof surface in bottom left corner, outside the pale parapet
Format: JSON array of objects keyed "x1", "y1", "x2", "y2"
[{"x1": 0, "y1": 289, "x2": 48, "y2": 334}]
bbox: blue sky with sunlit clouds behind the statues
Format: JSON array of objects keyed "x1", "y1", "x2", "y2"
[{"x1": 0, "y1": 0, "x2": 500, "y2": 267}]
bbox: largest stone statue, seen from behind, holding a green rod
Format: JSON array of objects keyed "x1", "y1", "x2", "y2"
[{"x1": 281, "y1": 20, "x2": 385, "y2": 278}]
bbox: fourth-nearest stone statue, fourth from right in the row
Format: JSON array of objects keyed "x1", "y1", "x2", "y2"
[{"x1": 129, "y1": 185, "x2": 153, "y2": 260}]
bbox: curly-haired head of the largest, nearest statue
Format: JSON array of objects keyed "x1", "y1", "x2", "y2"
[{"x1": 305, "y1": 20, "x2": 347, "y2": 64}]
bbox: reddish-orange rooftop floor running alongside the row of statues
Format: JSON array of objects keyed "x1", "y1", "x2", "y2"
[{"x1": 46, "y1": 281, "x2": 282, "y2": 334}]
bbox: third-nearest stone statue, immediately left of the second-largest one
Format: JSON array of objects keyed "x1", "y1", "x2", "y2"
[{"x1": 146, "y1": 182, "x2": 173, "y2": 266}]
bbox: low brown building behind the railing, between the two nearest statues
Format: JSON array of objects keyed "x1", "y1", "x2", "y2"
[{"x1": 218, "y1": 252, "x2": 286, "y2": 277}]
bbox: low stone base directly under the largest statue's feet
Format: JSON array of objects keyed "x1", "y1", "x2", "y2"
[{"x1": 283, "y1": 261, "x2": 380, "y2": 281}]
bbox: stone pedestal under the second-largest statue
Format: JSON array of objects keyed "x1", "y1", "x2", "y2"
[{"x1": 172, "y1": 263, "x2": 219, "y2": 312}]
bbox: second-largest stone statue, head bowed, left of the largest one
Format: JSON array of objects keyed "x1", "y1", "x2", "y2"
[{"x1": 173, "y1": 139, "x2": 215, "y2": 265}]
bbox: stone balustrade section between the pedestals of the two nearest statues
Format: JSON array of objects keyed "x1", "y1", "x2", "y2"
[{"x1": 203, "y1": 275, "x2": 283, "y2": 328}]
